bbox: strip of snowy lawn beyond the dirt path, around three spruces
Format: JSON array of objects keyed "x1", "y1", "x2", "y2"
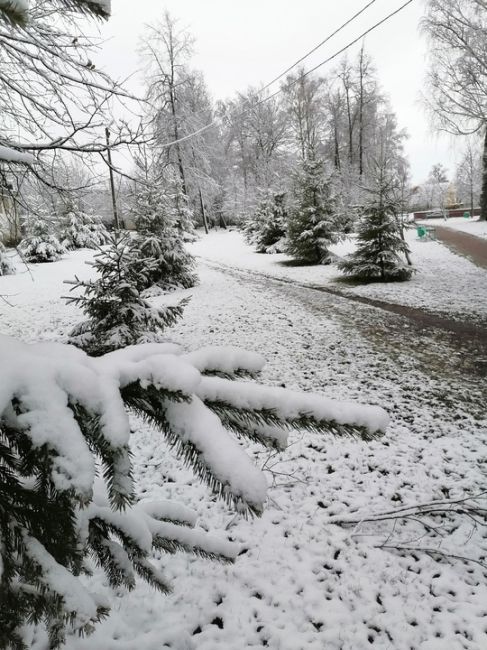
[{"x1": 190, "y1": 230, "x2": 487, "y2": 320}]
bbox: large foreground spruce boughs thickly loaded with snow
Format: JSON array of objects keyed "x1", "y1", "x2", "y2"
[{"x1": 0, "y1": 336, "x2": 388, "y2": 650}]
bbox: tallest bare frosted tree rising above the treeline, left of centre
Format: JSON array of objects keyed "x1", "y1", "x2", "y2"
[{"x1": 142, "y1": 12, "x2": 219, "y2": 228}]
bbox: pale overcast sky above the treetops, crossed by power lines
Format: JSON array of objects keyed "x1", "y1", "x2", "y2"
[{"x1": 97, "y1": 0, "x2": 464, "y2": 182}]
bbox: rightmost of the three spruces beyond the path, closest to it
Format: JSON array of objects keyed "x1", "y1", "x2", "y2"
[{"x1": 338, "y1": 166, "x2": 414, "y2": 282}]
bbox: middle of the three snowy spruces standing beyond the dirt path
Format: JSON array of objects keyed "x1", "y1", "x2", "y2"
[{"x1": 287, "y1": 158, "x2": 339, "y2": 264}]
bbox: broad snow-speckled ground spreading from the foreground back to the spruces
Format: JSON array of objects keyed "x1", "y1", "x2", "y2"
[{"x1": 0, "y1": 246, "x2": 487, "y2": 650}]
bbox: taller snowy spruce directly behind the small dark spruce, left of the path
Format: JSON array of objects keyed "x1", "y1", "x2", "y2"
[{"x1": 135, "y1": 177, "x2": 197, "y2": 291}]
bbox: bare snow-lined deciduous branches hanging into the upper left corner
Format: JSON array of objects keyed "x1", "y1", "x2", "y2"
[{"x1": 0, "y1": 0, "x2": 147, "y2": 219}]
